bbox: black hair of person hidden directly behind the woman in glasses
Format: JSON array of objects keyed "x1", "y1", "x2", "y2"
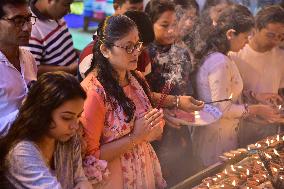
[{"x1": 124, "y1": 10, "x2": 155, "y2": 46}]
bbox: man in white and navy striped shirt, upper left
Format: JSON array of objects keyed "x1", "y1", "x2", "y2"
[{"x1": 28, "y1": 0, "x2": 78, "y2": 74}]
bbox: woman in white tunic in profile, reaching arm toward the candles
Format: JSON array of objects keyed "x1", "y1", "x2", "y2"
[{"x1": 193, "y1": 5, "x2": 277, "y2": 167}]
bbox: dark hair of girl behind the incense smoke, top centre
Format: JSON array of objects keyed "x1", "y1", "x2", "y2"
[{"x1": 145, "y1": 0, "x2": 175, "y2": 24}]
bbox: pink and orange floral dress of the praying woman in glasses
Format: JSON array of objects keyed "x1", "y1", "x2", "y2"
[{"x1": 81, "y1": 73, "x2": 166, "y2": 189}]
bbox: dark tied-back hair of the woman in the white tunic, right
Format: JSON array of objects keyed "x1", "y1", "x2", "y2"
[{"x1": 191, "y1": 4, "x2": 254, "y2": 66}]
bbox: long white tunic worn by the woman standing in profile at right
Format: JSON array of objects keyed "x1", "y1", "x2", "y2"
[{"x1": 193, "y1": 53, "x2": 245, "y2": 167}]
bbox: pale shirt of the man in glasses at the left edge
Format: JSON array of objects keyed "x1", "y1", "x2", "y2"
[{"x1": 0, "y1": 48, "x2": 37, "y2": 136}]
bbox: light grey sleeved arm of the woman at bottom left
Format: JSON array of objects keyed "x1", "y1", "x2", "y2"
[{"x1": 6, "y1": 141, "x2": 62, "y2": 189}]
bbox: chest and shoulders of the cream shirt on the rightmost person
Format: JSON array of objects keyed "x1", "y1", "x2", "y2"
[{"x1": 230, "y1": 44, "x2": 284, "y2": 93}]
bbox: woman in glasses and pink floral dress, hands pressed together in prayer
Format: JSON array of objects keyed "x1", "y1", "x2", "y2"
[{"x1": 82, "y1": 15, "x2": 166, "y2": 189}]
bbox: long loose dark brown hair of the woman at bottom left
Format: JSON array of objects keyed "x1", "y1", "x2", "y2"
[{"x1": 0, "y1": 72, "x2": 87, "y2": 171}]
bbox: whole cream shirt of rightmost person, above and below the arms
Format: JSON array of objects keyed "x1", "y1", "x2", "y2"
[{"x1": 230, "y1": 44, "x2": 284, "y2": 146}]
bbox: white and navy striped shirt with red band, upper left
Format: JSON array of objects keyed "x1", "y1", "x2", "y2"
[{"x1": 28, "y1": 4, "x2": 77, "y2": 66}]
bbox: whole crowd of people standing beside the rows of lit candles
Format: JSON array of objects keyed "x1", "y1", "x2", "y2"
[{"x1": 0, "y1": 0, "x2": 284, "y2": 189}]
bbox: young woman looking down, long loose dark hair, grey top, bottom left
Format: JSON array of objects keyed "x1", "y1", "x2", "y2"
[{"x1": 0, "y1": 72, "x2": 91, "y2": 189}]
